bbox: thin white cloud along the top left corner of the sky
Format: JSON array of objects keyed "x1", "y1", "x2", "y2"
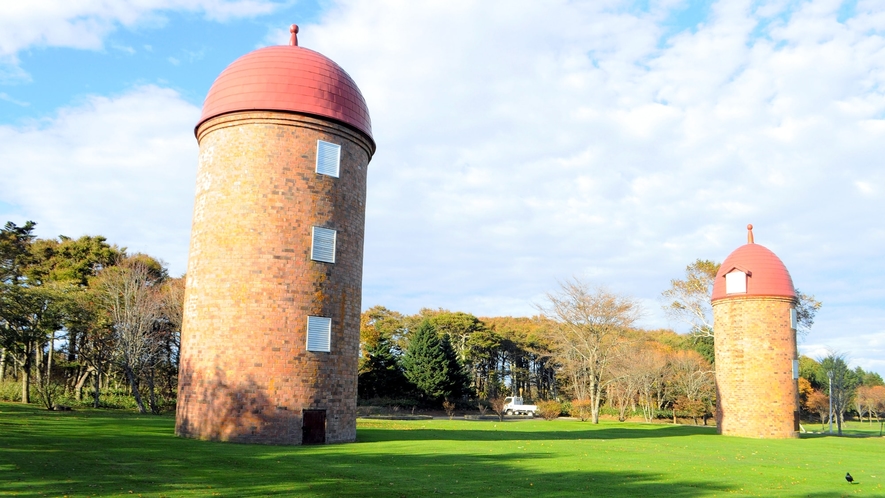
[{"x1": 0, "y1": 0, "x2": 281, "y2": 56}]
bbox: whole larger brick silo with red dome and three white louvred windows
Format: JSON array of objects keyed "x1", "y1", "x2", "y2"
[{"x1": 175, "y1": 25, "x2": 375, "y2": 444}]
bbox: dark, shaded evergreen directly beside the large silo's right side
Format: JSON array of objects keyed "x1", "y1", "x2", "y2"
[{"x1": 357, "y1": 337, "x2": 412, "y2": 399}]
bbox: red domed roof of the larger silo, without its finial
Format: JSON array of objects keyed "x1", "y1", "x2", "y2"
[{"x1": 197, "y1": 45, "x2": 372, "y2": 140}]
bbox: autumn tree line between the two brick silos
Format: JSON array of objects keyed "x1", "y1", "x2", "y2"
[{"x1": 359, "y1": 280, "x2": 715, "y2": 422}]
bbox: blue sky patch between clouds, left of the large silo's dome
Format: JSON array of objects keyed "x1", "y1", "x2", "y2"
[{"x1": 2, "y1": 2, "x2": 322, "y2": 120}]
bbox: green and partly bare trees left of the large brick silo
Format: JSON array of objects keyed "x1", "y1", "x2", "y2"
[{"x1": 0, "y1": 221, "x2": 184, "y2": 413}]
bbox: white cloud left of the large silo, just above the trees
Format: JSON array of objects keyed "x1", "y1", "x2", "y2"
[{"x1": 0, "y1": 86, "x2": 199, "y2": 274}]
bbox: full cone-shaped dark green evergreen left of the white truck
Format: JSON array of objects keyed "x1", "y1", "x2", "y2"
[{"x1": 403, "y1": 320, "x2": 467, "y2": 402}]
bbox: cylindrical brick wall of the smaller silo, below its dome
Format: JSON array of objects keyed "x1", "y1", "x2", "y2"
[{"x1": 713, "y1": 297, "x2": 799, "y2": 438}]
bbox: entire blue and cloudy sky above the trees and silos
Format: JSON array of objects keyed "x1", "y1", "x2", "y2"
[{"x1": 0, "y1": 0, "x2": 885, "y2": 374}]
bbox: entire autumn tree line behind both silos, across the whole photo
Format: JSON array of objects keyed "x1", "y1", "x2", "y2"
[{"x1": 0, "y1": 221, "x2": 885, "y2": 429}]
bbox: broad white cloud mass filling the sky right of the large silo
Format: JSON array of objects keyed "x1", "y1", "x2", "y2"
[{"x1": 288, "y1": 0, "x2": 885, "y2": 370}]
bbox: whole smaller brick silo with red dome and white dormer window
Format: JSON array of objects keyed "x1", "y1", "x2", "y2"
[{"x1": 712, "y1": 225, "x2": 799, "y2": 438}]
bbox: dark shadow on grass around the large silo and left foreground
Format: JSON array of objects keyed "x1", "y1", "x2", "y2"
[{"x1": 0, "y1": 405, "x2": 729, "y2": 498}]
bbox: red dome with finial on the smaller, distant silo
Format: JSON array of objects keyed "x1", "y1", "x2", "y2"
[{"x1": 712, "y1": 225, "x2": 796, "y2": 301}]
